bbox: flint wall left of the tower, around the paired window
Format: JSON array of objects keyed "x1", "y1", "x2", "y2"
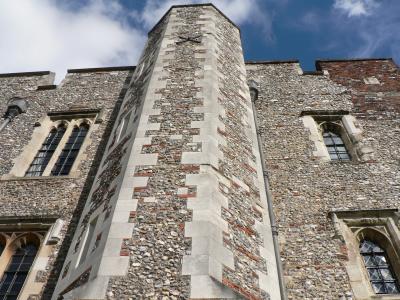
[{"x1": 0, "y1": 68, "x2": 132, "y2": 299}]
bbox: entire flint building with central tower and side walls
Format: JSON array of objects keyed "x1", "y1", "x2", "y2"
[{"x1": 0, "y1": 4, "x2": 400, "y2": 300}]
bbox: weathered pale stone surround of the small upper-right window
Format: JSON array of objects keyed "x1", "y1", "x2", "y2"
[{"x1": 300, "y1": 111, "x2": 373, "y2": 163}]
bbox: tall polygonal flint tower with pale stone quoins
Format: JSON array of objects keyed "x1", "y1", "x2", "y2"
[{"x1": 53, "y1": 5, "x2": 280, "y2": 299}]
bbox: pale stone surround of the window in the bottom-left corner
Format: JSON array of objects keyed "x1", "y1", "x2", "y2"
[{"x1": 0, "y1": 217, "x2": 59, "y2": 300}]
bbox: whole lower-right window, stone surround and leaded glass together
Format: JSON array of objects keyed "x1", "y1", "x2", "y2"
[{"x1": 330, "y1": 208, "x2": 400, "y2": 299}]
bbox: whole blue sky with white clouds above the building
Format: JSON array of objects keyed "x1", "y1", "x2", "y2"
[{"x1": 0, "y1": 0, "x2": 400, "y2": 79}]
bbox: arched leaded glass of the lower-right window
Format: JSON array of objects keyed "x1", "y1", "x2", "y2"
[{"x1": 360, "y1": 240, "x2": 400, "y2": 294}]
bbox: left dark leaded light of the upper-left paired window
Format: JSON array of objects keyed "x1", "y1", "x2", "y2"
[{"x1": 25, "y1": 125, "x2": 65, "y2": 177}]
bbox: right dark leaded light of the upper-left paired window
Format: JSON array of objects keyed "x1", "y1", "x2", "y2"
[{"x1": 51, "y1": 124, "x2": 89, "y2": 176}]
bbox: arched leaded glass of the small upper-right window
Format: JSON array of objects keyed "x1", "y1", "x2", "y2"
[{"x1": 321, "y1": 122, "x2": 351, "y2": 161}]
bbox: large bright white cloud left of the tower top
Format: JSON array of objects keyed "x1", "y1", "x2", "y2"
[{"x1": 0, "y1": 0, "x2": 145, "y2": 80}]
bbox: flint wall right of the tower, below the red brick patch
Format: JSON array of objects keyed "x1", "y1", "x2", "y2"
[{"x1": 247, "y1": 62, "x2": 400, "y2": 299}]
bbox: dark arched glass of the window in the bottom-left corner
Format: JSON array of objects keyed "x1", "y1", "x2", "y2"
[{"x1": 0, "y1": 244, "x2": 37, "y2": 300}]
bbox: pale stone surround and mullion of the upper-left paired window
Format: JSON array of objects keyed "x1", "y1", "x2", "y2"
[{"x1": 1, "y1": 109, "x2": 103, "y2": 180}]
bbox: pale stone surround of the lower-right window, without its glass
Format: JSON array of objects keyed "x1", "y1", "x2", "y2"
[{"x1": 329, "y1": 209, "x2": 400, "y2": 300}]
